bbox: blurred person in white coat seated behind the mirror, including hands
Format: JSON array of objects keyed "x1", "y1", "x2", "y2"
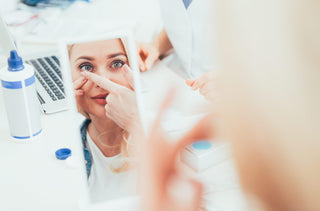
[{"x1": 138, "y1": 0, "x2": 218, "y2": 100}]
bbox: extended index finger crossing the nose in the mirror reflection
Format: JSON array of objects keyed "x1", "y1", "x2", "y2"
[{"x1": 81, "y1": 72, "x2": 127, "y2": 92}]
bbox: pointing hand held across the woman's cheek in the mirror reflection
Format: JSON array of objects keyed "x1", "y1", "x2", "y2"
[{"x1": 81, "y1": 65, "x2": 140, "y2": 133}]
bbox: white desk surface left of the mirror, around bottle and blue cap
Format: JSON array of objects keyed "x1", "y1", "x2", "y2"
[{"x1": 0, "y1": 96, "x2": 83, "y2": 211}]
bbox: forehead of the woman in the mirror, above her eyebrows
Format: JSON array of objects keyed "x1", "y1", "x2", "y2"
[{"x1": 70, "y1": 38, "x2": 125, "y2": 57}]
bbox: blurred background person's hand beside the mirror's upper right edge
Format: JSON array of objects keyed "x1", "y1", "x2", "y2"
[{"x1": 137, "y1": 42, "x2": 160, "y2": 72}]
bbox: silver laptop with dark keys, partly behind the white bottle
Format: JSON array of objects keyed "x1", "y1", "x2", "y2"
[{"x1": 0, "y1": 16, "x2": 67, "y2": 114}]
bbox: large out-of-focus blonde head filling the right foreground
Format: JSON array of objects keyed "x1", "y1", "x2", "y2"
[{"x1": 217, "y1": 0, "x2": 320, "y2": 211}]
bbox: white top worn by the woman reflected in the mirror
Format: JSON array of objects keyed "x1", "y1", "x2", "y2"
[{"x1": 87, "y1": 133, "x2": 136, "y2": 202}]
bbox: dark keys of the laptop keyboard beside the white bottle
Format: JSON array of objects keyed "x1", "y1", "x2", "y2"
[{"x1": 26, "y1": 56, "x2": 65, "y2": 101}]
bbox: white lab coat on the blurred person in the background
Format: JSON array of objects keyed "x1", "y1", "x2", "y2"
[{"x1": 159, "y1": 0, "x2": 218, "y2": 78}]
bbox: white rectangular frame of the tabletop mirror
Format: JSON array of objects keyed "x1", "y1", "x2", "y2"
[{"x1": 59, "y1": 25, "x2": 142, "y2": 211}]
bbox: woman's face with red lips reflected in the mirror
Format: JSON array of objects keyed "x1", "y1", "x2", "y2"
[{"x1": 69, "y1": 39, "x2": 129, "y2": 117}]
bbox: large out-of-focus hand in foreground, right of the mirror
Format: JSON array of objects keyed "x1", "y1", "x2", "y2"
[{"x1": 140, "y1": 92, "x2": 213, "y2": 211}]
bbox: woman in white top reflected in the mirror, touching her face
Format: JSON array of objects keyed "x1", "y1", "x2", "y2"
[{"x1": 69, "y1": 39, "x2": 136, "y2": 201}]
